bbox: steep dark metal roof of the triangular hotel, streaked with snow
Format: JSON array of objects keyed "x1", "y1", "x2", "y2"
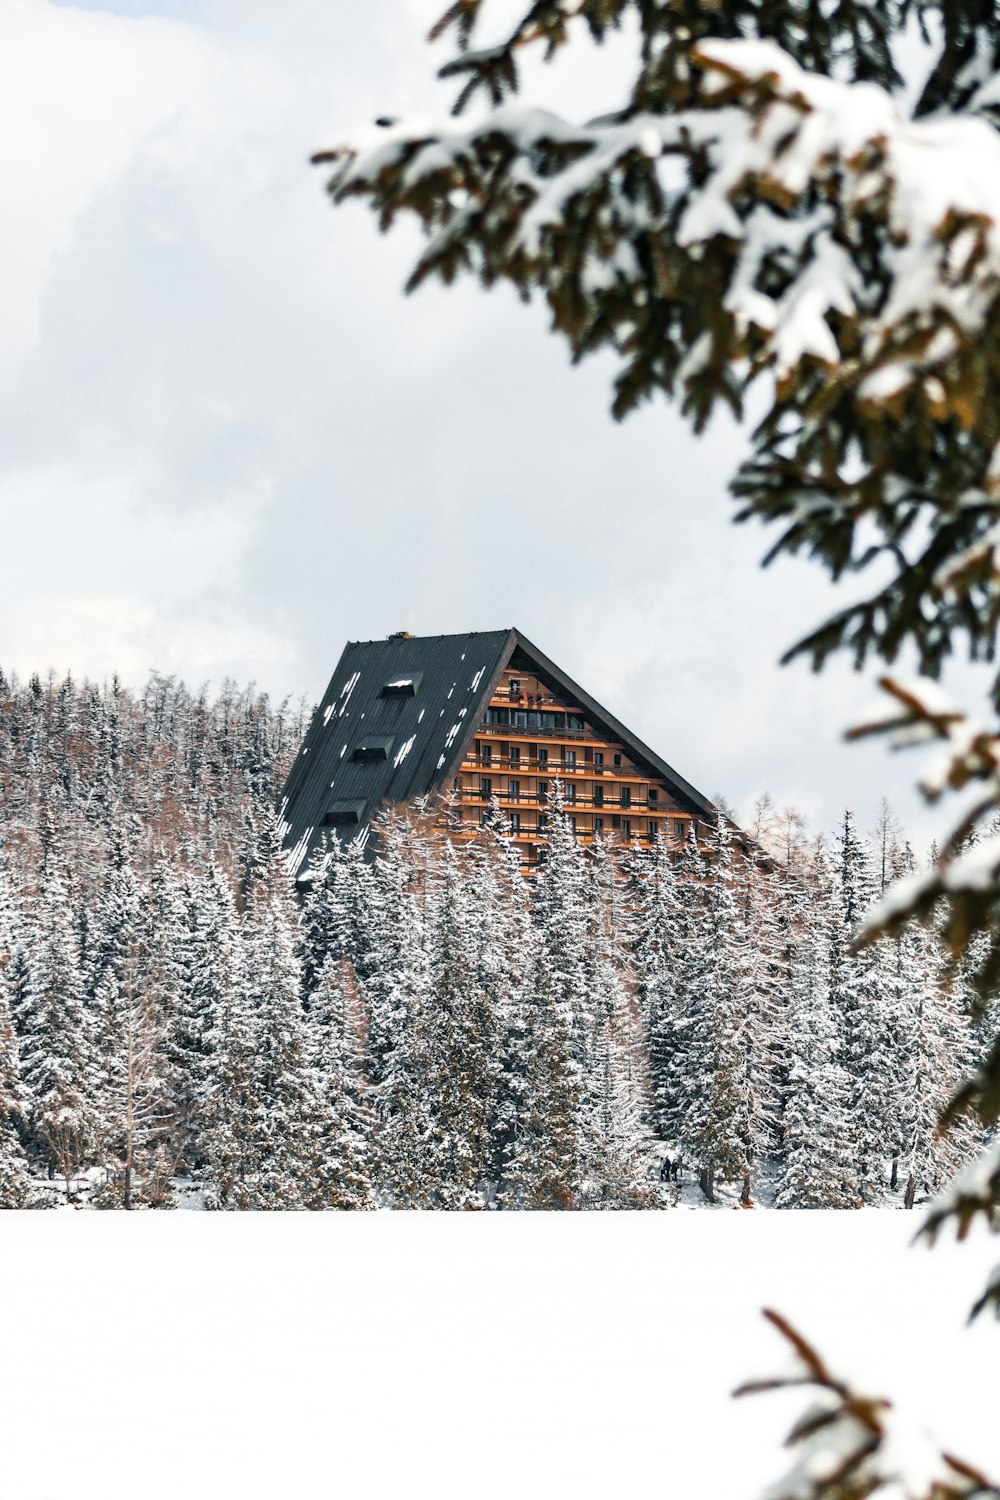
[{"x1": 280, "y1": 630, "x2": 714, "y2": 873}]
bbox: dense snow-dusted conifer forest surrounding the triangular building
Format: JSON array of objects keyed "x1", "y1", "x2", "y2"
[{"x1": 0, "y1": 675, "x2": 991, "y2": 1209}]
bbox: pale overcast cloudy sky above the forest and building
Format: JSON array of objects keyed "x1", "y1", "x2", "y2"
[{"x1": 0, "y1": 0, "x2": 983, "y2": 839}]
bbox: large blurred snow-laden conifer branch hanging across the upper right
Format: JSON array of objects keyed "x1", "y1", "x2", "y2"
[{"x1": 313, "y1": 26, "x2": 1000, "y2": 674}]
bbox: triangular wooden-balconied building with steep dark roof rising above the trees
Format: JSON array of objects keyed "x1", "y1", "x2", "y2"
[{"x1": 280, "y1": 630, "x2": 714, "y2": 878}]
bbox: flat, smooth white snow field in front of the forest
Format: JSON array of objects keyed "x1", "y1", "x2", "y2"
[{"x1": 0, "y1": 1211, "x2": 1000, "y2": 1500}]
